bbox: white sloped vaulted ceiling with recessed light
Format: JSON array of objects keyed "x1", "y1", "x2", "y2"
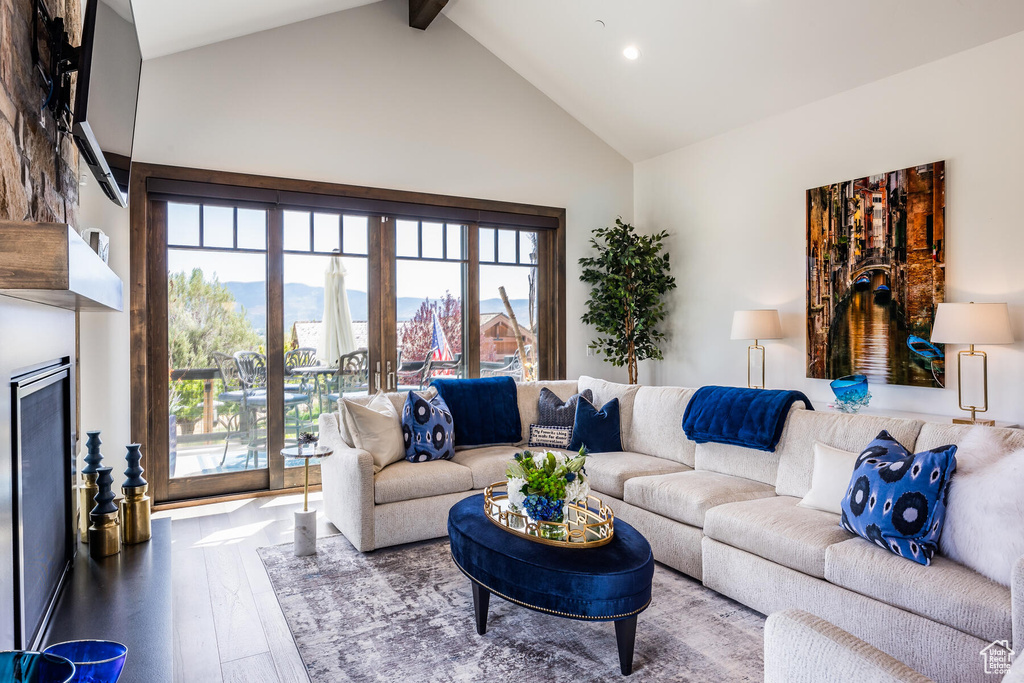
[{"x1": 132, "y1": 0, "x2": 1024, "y2": 162}]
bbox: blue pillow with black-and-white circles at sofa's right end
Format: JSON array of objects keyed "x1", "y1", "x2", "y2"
[{"x1": 841, "y1": 430, "x2": 956, "y2": 565}]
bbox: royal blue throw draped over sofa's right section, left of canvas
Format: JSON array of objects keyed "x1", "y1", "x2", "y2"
[{"x1": 683, "y1": 386, "x2": 814, "y2": 452}]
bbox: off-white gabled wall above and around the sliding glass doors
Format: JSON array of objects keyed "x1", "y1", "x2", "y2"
[{"x1": 81, "y1": 0, "x2": 633, "y2": 483}]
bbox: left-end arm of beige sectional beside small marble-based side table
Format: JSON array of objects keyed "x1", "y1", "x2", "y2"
[{"x1": 319, "y1": 413, "x2": 375, "y2": 552}]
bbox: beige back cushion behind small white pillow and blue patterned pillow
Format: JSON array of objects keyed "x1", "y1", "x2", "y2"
[{"x1": 774, "y1": 411, "x2": 924, "y2": 498}]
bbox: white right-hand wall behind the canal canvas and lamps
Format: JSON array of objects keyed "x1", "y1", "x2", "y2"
[{"x1": 635, "y1": 34, "x2": 1024, "y2": 424}]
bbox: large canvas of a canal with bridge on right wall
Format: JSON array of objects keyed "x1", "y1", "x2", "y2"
[{"x1": 807, "y1": 162, "x2": 946, "y2": 387}]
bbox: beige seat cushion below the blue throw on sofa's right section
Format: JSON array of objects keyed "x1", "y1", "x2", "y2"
[{"x1": 622, "y1": 471, "x2": 775, "y2": 526}]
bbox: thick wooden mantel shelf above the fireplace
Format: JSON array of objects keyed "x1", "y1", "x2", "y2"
[{"x1": 0, "y1": 221, "x2": 124, "y2": 310}]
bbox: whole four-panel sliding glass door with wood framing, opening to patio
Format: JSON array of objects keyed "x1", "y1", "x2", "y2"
[{"x1": 133, "y1": 167, "x2": 563, "y2": 504}]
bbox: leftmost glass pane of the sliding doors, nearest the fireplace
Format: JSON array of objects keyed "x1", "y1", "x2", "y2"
[{"x1": 166, "y1": 203, "x2": 268, "y2": 483}]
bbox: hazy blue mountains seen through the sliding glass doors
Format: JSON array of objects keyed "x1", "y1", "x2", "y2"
[{"x1": 223, "y1": 282, "x2": 529, "y2": 330}]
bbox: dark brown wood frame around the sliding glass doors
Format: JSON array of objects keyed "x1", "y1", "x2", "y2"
[{"x1": 129, "y1": 163, "x2": 566, "y2": 504}]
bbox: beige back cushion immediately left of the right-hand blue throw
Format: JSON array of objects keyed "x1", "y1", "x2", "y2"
[{"x1": 624, "y1": 387, "x2": 696, "y2": 467}]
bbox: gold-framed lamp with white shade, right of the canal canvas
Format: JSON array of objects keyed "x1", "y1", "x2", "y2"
[{"x1": 932, "y1": 301, "x2": 1014, "y2": 425}]
